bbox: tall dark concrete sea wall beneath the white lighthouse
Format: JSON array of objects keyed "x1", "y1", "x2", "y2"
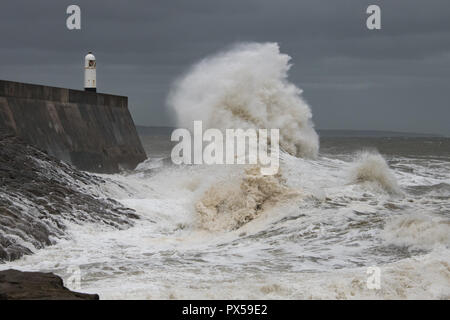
[{"x1": 0, "y1": 80, "x2": 146, "y2": 173}]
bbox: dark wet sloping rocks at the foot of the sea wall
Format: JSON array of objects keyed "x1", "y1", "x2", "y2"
[{"x1": 0, "y1": 135, "x2": 138, "y2": 263}]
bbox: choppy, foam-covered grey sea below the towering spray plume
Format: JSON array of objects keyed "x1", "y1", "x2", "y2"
[{"x1": 1, "y1": 136, "x2": 450, "y2": 299}]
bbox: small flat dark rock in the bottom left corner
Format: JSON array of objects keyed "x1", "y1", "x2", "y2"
[{"x1": 0, "y1": 269, "x2": 99, "y2": 300}]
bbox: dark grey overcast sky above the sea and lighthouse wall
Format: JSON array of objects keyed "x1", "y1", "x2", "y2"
[{"x1": 0, "y1": 0, "x2": 450, "y2": 135}]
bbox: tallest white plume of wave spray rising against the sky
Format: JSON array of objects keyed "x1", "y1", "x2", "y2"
[{"x1": 168, "y1": 43, "x2": 319, "y2": 157}]
